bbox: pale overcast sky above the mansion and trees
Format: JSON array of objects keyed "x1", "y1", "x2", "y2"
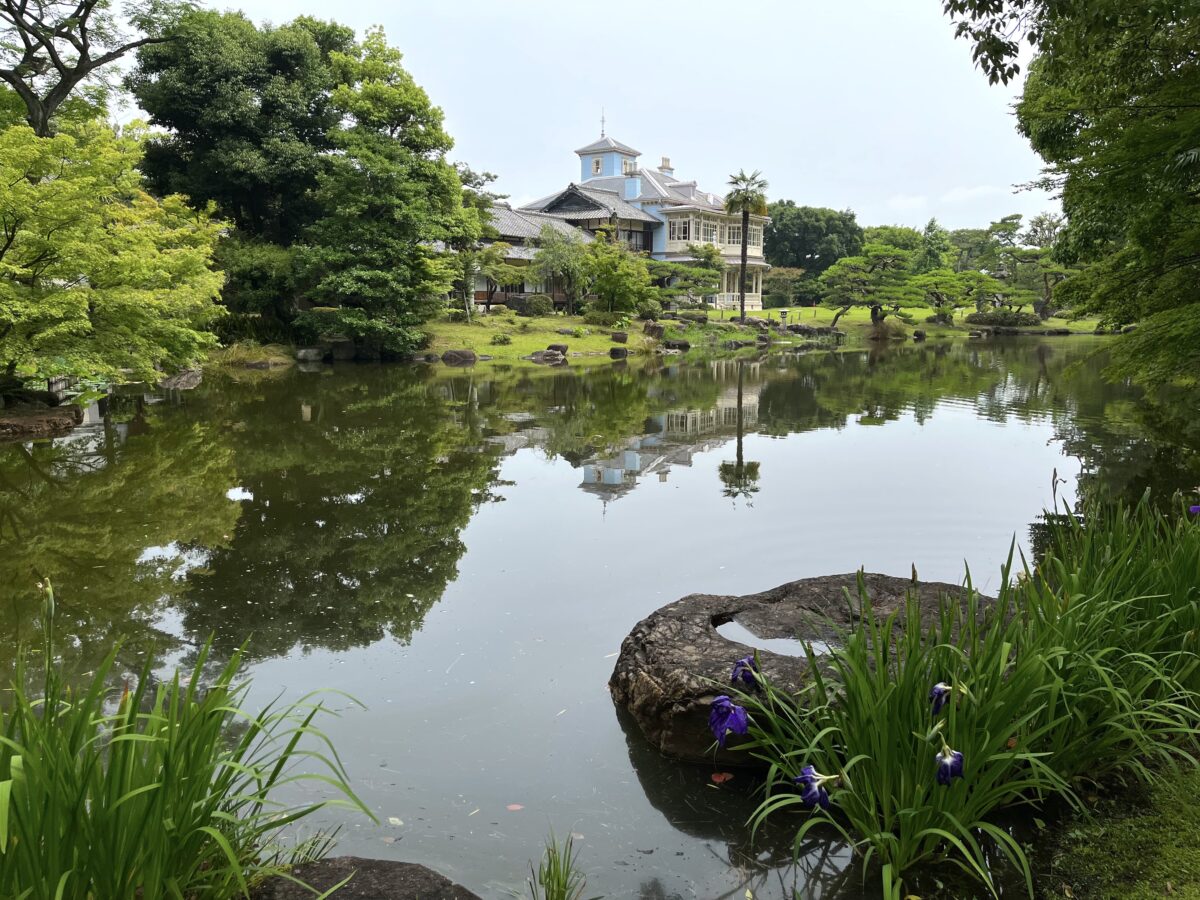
[{"x1": 212, "y1": 0, "x2": 1057, "y2": 228}]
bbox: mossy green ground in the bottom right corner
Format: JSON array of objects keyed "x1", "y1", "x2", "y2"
[{"x1": 1038, "y1": 769, "x2": 1200, "y2": 900}]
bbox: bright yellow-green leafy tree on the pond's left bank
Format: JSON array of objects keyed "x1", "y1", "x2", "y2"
[{"x1": 0, "y1": 121, "x2": 221, "y2": 394}]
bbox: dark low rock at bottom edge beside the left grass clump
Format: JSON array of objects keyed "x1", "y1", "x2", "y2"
[{"x1": 252, "y1": 857, "x2": 480, "y2": 900}]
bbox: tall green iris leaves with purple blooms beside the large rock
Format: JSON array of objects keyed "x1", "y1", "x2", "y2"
[{"x1": 737, "y1": 502, "x2": 1200, "y2": 898}]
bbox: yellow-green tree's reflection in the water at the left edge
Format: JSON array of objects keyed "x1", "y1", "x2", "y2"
[{"x1": 0, "y1": 404, "x2": 240, "y2": 681}]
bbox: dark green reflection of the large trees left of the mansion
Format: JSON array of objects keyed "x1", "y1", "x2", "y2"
[{"x1": 174, "y1": 368, "x2": 497, "y2": 654}]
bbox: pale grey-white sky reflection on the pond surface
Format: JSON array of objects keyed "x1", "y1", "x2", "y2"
[{"x1": 236, "y1": 403, "x2": 1078, "y2": 898}]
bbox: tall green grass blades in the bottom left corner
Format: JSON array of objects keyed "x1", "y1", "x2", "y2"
[{"x1": 0, "y1": 580, "x2": 370, "y2": 900}]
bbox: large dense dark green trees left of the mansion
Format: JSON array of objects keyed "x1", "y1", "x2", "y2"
[{"x1": 127, "y1": 11, "x2": 468, "y2": 354}]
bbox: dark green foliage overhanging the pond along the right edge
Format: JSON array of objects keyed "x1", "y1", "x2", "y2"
[{"x1": 944, "y1": 0, "x2": 1200, "y2": 382}]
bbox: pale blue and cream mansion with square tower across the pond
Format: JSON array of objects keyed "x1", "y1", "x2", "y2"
[{"x1": 476, "y1": 137, "x2": 768, "y2": 310}]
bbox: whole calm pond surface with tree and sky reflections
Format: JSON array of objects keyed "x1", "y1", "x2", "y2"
[{"x1": 0, "y1": 338, "x2": 1200, "y2": 900}]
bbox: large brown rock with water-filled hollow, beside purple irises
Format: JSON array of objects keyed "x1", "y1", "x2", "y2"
[{"x1": 608, "y1": 572, "x2": 984, "y2": 766}]
